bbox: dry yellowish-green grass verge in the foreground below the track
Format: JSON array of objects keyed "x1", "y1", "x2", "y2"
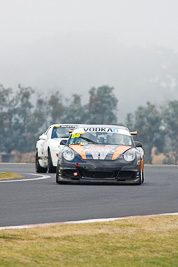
[{"x1": 0, "y1": 216, "x2": 178, "y2": 267}]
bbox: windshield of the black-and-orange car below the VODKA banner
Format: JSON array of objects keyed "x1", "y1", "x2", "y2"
[{"x1": 69, "y1": 132, "x2": 133, "y2": 146}]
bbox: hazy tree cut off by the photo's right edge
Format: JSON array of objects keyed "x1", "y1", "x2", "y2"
[{"x1": 164, "y1": 100, "x2": 178, "y2": 164}]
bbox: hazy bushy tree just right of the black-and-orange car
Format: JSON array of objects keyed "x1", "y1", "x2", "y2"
[{"x1": 126, "y1": 102, "x2": 165, "y2": 163}]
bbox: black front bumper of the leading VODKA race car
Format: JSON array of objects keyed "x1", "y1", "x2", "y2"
[{"x1": 57, "y1": 159, "x2": 141, "y2": 184}]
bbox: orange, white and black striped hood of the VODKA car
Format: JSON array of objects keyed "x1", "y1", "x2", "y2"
[{"x1": 69, "y1": 145, "x2": 132, "y2": 160}]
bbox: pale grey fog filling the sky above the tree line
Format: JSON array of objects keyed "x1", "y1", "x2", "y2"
[{"x1": 0, "y1": 0, "x2": 178, "y2": 121}]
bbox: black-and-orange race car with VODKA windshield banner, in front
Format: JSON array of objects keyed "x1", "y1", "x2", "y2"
[{"x1": 56, "y1": 125, "x2": 144, "y2": 185}]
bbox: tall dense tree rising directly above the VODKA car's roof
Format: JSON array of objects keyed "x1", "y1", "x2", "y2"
[{"x1": 87, "y1": 85, "x2": 118, "y2": 124}]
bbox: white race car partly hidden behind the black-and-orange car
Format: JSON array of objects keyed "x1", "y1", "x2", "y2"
[{"x1": 35, "y1": 124, "x2": 79, "y2": 173}]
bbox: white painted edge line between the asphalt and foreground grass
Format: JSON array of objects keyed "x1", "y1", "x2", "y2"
[{"x1": 0, "y1": 212, "x2": 178, "y2": 230}]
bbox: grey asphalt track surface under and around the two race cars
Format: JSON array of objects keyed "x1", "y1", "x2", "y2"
[{"x1": 0, "y1": 164, "x2": 178, "y2": 226}]
